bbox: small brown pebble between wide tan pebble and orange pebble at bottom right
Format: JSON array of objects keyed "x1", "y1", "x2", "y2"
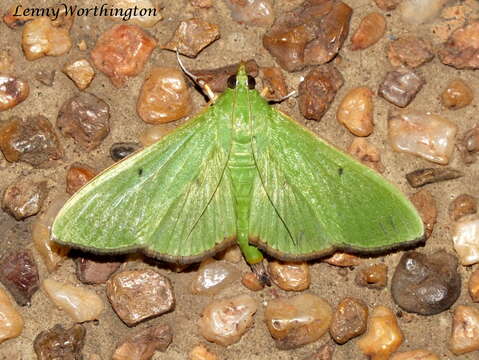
[{"x1": 329, "y1": 297, "x2": 368, "y2": 344}]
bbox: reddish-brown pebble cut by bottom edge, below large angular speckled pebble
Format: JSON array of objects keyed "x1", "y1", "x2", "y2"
[{"x1": 112, "y1": 325, "x2": 173, "y2": 360}]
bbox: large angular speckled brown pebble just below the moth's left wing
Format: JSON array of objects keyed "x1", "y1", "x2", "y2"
[{"x1": 106, "y1": 269, "x2": 175, "y2": 326}]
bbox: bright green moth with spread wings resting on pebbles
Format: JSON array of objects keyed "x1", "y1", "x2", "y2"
[{"x1": 52, "y1": 66, "x2": 424, "y2": 264}]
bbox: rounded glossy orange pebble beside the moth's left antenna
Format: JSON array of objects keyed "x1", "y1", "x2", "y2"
[{"x1": 136, "y1": 67, "x2": 191, "y2": 124}]
